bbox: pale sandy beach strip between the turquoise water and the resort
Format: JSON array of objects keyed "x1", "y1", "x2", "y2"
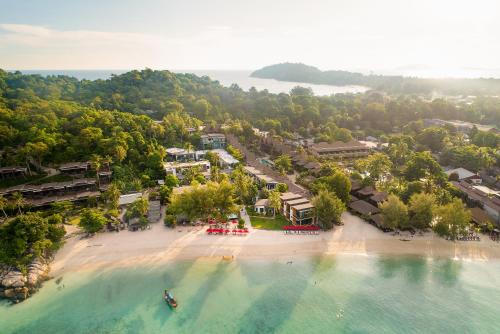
[{"x1": 50, "y1": 213, "x2": 500, "y2": 277}]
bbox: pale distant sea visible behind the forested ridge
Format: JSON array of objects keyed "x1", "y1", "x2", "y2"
[{"x1": 16, "y1": 70, "x2": 369, "y2": 96}]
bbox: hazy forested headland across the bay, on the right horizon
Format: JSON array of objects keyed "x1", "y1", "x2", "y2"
[{"x1": 251, "y1": 63, "x2": 500, "y2": 95}]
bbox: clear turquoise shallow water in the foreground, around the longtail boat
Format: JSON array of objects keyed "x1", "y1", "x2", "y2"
[{"x1": 0, "y1": 255, "x2": 500, "y2": 334}]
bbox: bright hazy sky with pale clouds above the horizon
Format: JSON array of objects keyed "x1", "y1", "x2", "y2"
[{"x1": 0, "y1": 0, "x2": 500, "y2": 76}]
